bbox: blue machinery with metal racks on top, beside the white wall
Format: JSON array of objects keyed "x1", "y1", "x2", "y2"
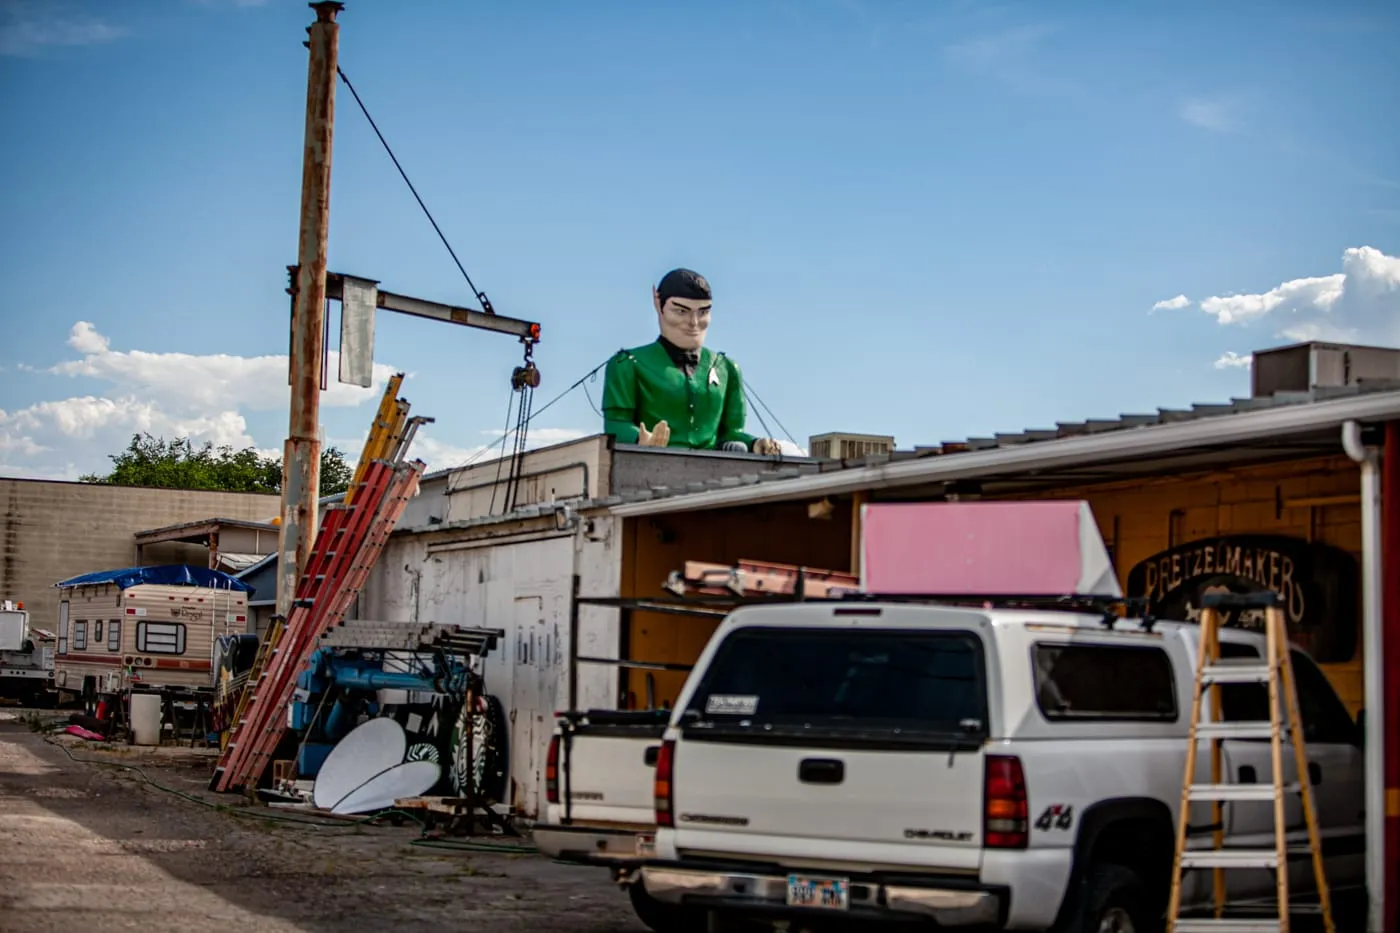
[{"x1": 288, "y1": 619, "x2": 504, "y2": 778}]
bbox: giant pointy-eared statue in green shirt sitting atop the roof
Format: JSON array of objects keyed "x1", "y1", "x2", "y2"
[{"x1": 603, "y1": 269, "x2": 778, "y2": 454}]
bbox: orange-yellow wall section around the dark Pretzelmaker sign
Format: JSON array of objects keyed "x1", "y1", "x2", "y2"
[{"x1": 1002, "y1": 457, "x2": 1362, "y2": 714}]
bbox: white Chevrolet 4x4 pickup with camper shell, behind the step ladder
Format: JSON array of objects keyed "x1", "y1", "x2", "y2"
[{"x1": 641, "y1": 602, "x2": 1364, "y2": 933}]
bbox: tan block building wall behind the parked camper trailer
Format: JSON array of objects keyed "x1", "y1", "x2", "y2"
[{"x1": 0, "y1": 478, "x2": 281, "y2": 630}]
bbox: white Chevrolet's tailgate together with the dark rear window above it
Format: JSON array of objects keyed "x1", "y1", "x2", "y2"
[{"x1": 671, "y1": 616, "x2": 987, "y2": 873}]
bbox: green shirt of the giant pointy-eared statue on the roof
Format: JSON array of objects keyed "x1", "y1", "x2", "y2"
[{"x1": 603, "y1": 340, "x2": 755, "y2": 450}]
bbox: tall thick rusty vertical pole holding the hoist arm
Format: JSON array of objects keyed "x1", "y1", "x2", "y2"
[{"x1": 277, "y1": 0, "x2": 344, "y2": 615}]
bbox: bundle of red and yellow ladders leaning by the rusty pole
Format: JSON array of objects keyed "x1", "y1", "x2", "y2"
[{"x1": 210, "y1": 374, "x2": 431, "y2": 792}]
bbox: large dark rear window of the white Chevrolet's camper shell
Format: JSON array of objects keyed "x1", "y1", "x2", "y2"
[{"x1": 689, "y1": 628, "x2": 987, "y2": 735}]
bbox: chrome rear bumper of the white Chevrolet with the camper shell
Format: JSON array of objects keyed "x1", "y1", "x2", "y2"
[{"x1": 641, "y1": 863, "x2": 1007, "y2": 927}]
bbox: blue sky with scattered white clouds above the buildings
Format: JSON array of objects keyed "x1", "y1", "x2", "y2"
[{"x1": 0, "y1": 0, "x2": 1400, "y2": 476}]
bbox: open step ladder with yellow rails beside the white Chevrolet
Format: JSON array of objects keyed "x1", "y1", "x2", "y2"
[{"x1": 1166, "y1": 593, "x2": 1337, "y2": 933}]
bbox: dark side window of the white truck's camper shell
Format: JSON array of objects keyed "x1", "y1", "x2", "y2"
[{"x1": 1032, "y1": 644, "x2": 1176, "y2": 723}]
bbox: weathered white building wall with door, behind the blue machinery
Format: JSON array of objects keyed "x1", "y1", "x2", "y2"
[{"x1": 361, "y1": 516, "x2": 622, "y2": 818}]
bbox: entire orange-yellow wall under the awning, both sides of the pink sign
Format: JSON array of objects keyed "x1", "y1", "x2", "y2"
[{"x1": 622, "y1": 457, "x2": 1362, "y2": 713}]
